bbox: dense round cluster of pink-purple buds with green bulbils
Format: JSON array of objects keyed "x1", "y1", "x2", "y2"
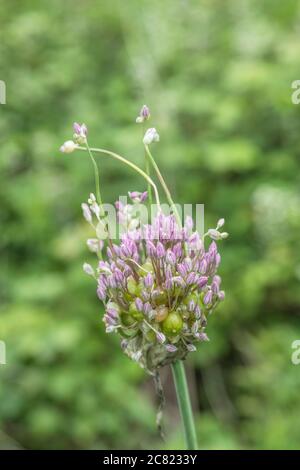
[{"x1": 84, "y1": 197, "x2": 225, "y2": 373}]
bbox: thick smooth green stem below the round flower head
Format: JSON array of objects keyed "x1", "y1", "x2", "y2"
[{"x1": 171, "y1": 361, "x2": 198, "y2": 450}]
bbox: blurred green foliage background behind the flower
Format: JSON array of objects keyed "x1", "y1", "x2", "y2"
[{"x1": 0, "y1": 0, "x2": 300, "y2": 449}]
